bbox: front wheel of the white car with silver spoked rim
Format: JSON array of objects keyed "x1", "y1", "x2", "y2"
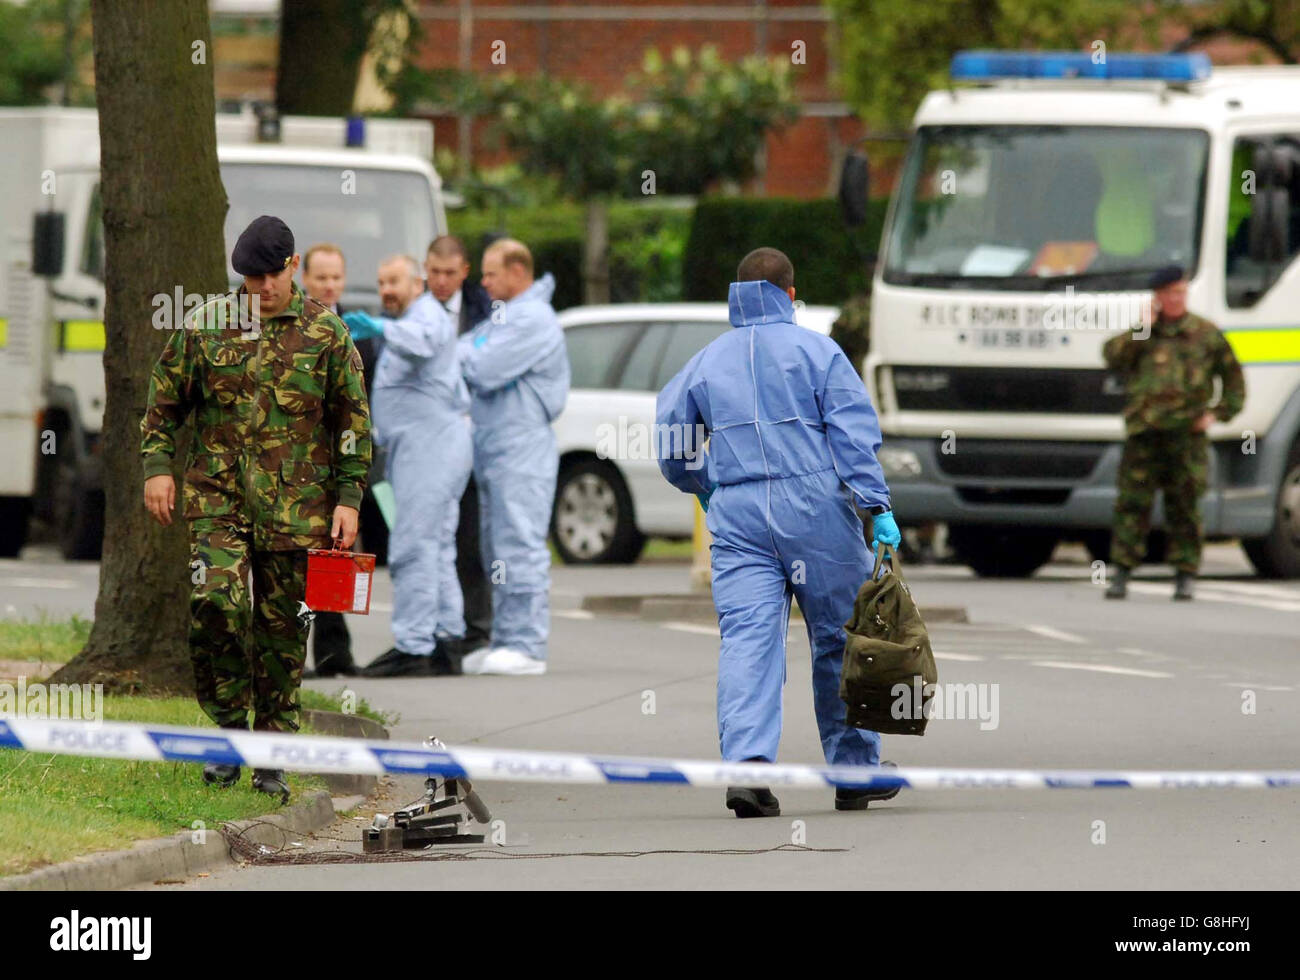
[{"x1": 551, "y1": 459, "x2": 646, "y2": 565}]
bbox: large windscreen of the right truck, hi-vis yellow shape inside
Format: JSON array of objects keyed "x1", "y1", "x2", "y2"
[{"x1": 883, "y1": 126, "x2": 1209, "y2": 290}]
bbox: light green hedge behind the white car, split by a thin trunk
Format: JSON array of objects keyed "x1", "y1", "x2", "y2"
[{"x1": 447, "y1": 201, "x2": 692, "y2": 309}]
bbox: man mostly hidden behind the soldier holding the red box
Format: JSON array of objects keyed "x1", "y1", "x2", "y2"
[{"x1": 303, "y1": 242, "x2": 389, "y2": 677}]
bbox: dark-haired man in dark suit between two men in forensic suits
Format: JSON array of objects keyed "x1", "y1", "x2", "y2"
[{"x1": 426, "y1": 235, "x2": 491, "y2": 654}]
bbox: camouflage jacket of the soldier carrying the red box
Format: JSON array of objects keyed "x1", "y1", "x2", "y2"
[{"x1": 140, "y1": 285, "x2": 371, "y2": 551}]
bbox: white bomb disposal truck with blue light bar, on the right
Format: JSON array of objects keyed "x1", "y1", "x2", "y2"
[{"x1": 846, "y1": 52, "x2": 1300, "y2": 577}]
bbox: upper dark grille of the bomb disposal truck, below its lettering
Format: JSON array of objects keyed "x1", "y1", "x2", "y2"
[{"x1": 891, "y1": 364, "x2": 1125, "y2": 415}]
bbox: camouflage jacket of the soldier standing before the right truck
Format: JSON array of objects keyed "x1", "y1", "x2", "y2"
[{"x1": 1102, "y1": 313, "x2": 1245, "y2": 435}]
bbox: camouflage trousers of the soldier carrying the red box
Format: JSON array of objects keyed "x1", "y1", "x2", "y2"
[{"x1": 190, "y1": 520, "x2": 309, "y2": 732}]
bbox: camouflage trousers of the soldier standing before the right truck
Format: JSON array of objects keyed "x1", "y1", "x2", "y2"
[{"x1": 1110, "y1": 429, "x2": 1209, "y2": 573}]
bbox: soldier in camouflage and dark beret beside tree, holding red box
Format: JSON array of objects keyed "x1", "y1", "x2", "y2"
[{"x1": 140, "y1": 216, "x2": 371, "y2": 798}]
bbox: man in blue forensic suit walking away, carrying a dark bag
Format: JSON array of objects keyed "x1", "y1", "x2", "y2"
[{"x1": 657, "y1": 248, "x2": 900, "y2": 816}]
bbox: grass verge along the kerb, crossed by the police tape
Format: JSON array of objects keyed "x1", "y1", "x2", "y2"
[{"x1": 0, "y1": 695, "x2": 335, "y2": 875}]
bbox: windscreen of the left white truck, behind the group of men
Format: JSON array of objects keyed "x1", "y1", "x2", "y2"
[{"x1": 221, "y1": 162, "x2": 438, "y2": 305}]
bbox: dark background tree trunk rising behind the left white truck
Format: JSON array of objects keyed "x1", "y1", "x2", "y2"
[{"x1": 276, "y1": 0, "x2": 373, "y2": 116}]
